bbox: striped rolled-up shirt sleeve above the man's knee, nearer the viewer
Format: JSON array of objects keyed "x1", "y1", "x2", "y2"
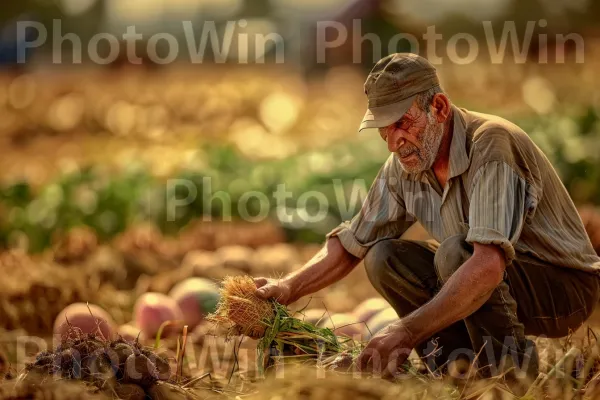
[{"x1": 466, "y1": 161, "x2": 528, "y2": 263}]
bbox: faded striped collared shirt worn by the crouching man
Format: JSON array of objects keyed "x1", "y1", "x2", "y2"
[{"x1": 327, "y1": 106, "x2": 600, "y2": 274}]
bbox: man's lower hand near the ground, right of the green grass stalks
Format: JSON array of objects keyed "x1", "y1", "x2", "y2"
[{"x1": 356, "y1": 322, "x2": 417, "y2": 378}]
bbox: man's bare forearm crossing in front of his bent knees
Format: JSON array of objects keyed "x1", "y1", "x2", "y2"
[{"x1": 401, "y1": 247, "x2": 504, "y2": 344}]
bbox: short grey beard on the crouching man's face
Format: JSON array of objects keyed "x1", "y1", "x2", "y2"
[{"x1": 397, "y1": 112, "x2": 444, "y2": 174}]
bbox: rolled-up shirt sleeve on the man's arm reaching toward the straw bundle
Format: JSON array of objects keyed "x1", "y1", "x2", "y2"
[{"x1": 327, "y1": 158, "x2": 413, "y2": 258}]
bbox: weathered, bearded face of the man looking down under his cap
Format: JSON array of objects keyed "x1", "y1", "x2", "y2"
[{"x1": 379, "y1": 103, "x2": 444, "y2": 174}]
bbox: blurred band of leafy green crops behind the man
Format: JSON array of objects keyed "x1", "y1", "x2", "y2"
[{"x1": 0, "y1": 107, "x2": 600, "y2": 252}]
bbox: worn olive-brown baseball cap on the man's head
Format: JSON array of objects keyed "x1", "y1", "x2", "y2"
[{"x1": 358, "y1": 53, "x2": 440, "y2": 131}]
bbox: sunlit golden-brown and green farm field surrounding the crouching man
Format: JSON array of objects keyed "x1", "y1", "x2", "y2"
[{"x1": 0, "y1": 59, "x2": 600, "y2": 399}]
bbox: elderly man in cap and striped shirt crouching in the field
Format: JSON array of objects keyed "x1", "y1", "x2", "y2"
[{"x1": 256, "y1": 54, "x2": 600, "y2": 378}]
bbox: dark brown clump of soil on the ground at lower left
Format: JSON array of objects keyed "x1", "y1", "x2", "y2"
[{"x1": 18, "y1": 328, "x2": 171, "y2": 399}]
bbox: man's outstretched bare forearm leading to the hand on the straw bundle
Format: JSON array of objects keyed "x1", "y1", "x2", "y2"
[{"x1": 283, "y1": 236, "x2": 360, "y2": 301}]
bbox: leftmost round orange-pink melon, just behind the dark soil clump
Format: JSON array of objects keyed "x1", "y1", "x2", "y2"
[{"x1": 54, "y1": 303, "x2": 116, "y2": 339}]
